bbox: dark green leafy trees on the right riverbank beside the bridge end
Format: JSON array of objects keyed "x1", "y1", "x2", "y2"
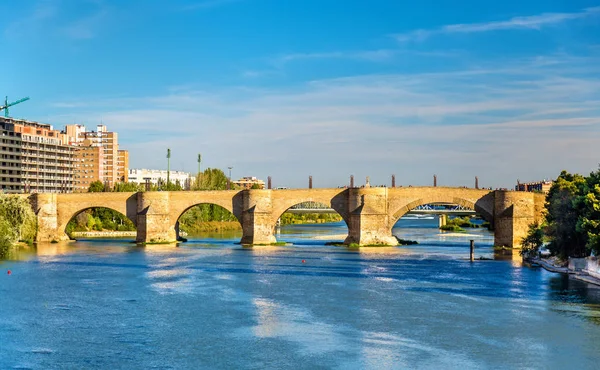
[{"x1": 522, "y1": 169, "x2": 600, "y2": 259}]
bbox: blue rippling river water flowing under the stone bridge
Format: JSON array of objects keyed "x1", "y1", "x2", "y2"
[{"x1": 0, "y1": 219, "x2": 600, "y2": 369}]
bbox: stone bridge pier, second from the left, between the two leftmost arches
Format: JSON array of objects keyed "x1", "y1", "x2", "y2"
[{"x1": 136, "y1": 191, "x2": 177, "y2": 244}]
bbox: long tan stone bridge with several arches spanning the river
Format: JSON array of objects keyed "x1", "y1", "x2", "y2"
[{"x1": 30, "y1": 187, "x2": 545, "y2": 247}]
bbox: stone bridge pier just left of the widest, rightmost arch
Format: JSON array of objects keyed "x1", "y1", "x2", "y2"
[{"x1": 344, "y1": 188, "x2": 398, "y2": 246}]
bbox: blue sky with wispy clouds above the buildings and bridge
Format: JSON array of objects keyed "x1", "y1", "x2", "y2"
[{"x1": 0, "y1": 0, "x2": 600, "y2": 187}]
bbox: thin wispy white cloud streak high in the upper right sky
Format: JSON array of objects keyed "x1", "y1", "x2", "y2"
[{"x1": 394, "y1": 7, "x2": 600, "y2": 42}]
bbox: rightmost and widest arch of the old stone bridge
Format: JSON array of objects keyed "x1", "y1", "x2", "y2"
[{"x1": 389, "y1": 193, "x2": 494, "y2": 232}]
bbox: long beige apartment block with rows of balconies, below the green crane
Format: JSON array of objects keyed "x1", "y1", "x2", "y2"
[{"x1": 0, "y1": 117, "x2": 75, "y2": 193}]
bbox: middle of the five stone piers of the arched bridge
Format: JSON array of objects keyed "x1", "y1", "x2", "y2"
[{"x1": 240, "y1": 189, "x2": 277, "y2": 245}]
